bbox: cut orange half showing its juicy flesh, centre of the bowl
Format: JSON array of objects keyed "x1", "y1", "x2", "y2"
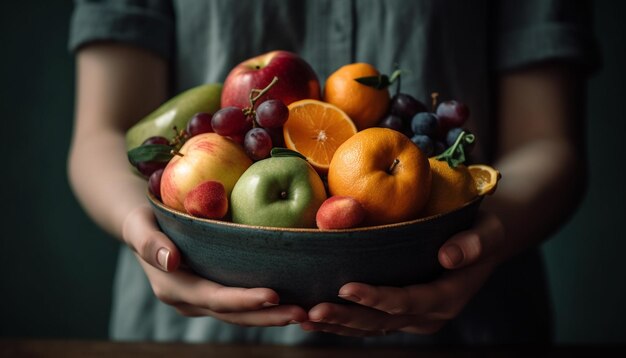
[{"x1": 283, "y1": 99, "x2": 357, "y2": 174}]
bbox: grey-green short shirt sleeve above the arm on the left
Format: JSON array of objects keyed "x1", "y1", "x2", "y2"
[{"x1": 68, "y1": 0, "x2": 175, "y2": 59}]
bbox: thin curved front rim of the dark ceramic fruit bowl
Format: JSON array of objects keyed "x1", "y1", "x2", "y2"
[{"x1": 147, "y1": 190, "x2": 485, "y2": 234}]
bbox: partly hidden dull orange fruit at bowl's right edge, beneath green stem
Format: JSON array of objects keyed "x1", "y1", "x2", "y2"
[{"x1": 422, "y1": 157, "x2": 478, "y2": 216}]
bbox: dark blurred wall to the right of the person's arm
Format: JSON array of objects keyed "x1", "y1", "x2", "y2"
[{"x1": 544, "y1": 0, "x2": 626, "y2": 343}]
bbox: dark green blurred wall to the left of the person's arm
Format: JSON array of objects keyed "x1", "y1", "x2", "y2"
[{"x1": 0, "y1": 0, "x2": 117, "y2": 337}]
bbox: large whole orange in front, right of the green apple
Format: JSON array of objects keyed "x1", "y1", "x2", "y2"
[{"x1": 328, "y1": 128, "x2": 431, "y2": 225}]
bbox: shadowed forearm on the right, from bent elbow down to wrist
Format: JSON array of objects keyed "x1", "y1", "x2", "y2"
[{"x1": 483, "y1": 139, "x2": 586, "y2": 260}]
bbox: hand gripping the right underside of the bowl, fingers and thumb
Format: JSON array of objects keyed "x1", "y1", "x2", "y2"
[{"x1": 300, "y1": 214, "x2": 504, "y2": 337}]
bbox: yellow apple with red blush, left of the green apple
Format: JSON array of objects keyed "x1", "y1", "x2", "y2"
[{"x1": 161, "y1": 133, "x2": 252, "y2": 212}]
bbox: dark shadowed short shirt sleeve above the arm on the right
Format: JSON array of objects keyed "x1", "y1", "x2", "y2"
[{"x1": 494, "y1": 0, "x2": 601, "y2": 72}]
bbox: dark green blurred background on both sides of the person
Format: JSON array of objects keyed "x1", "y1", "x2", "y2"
[{"x1": 0, "y1": 0, "x2": 626, "y2": 343}]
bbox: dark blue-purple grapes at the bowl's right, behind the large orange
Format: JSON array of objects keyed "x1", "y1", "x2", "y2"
[{"x1": 378, "y1": 93, "x2": 471, "y2": 157}]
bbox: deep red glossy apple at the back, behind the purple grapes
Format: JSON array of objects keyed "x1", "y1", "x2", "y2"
[{"x1": 221, "y1": 51, "x2": 321, "y2": 108}]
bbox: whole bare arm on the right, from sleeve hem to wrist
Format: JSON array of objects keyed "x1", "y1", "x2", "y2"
[{"x1": 485, "y1": 64, "x2": 587, "y2": 258}]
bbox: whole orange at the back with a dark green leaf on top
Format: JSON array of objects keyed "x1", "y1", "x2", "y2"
[{"x1": 324, "y1": 62, "x2": 390, "y2": 130}]
